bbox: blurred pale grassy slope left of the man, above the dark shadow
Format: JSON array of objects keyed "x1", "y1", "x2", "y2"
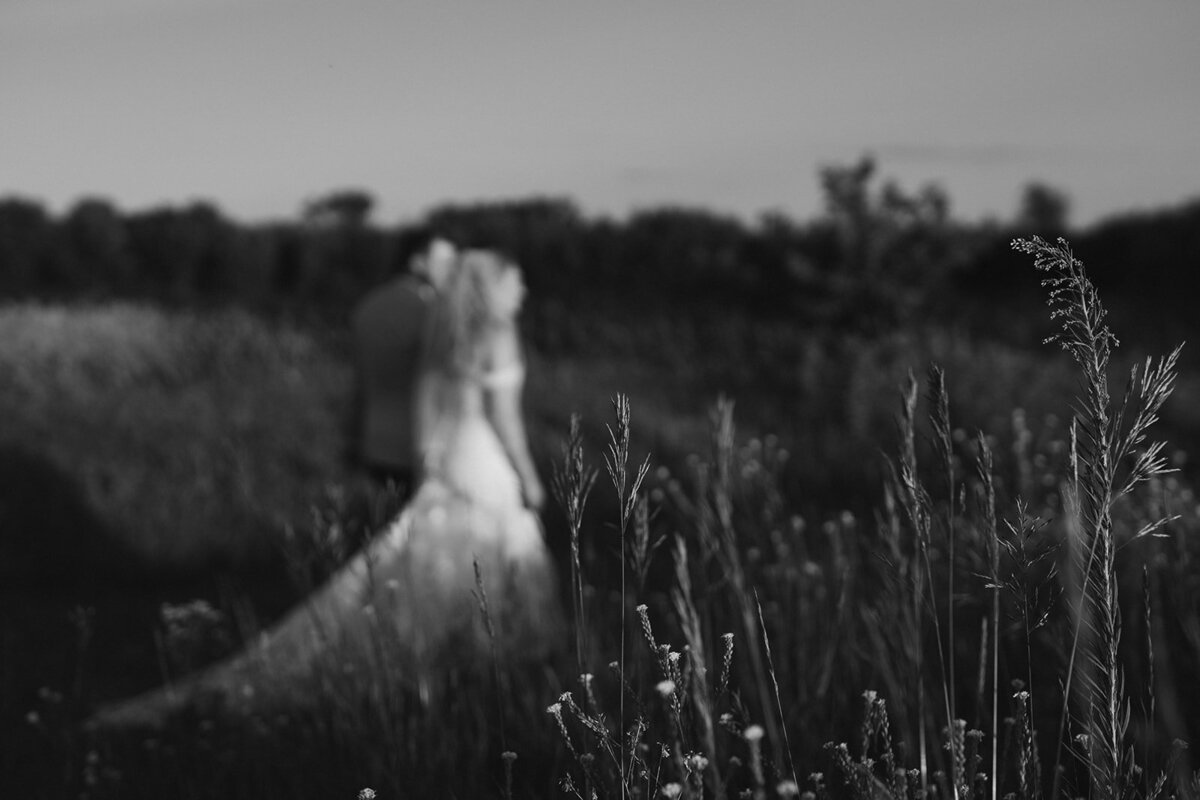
[{"x1": 0, "y1": 305, "x2": 349, "y2": 566}]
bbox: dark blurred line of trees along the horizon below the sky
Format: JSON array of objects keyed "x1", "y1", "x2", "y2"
[{"x1": 0, "y1": 157, "x2": 1200, "y2": 352}]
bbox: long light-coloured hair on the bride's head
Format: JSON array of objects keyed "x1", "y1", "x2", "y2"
[{"x1": 425, "y1": 249, "x2": 520, "y2": 377}]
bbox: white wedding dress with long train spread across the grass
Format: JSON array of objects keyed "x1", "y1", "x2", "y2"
[{"x1": 91, "y1": 363, "x2": 562, "y2": 728}]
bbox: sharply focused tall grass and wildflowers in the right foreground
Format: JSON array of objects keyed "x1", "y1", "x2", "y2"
[{"x1": 550, "y1": 239, "x2": 1195, "y2": 799}]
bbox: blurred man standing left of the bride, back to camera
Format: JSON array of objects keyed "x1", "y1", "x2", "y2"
[{"x1": 350, "y1": 230, "x2": 457, "y2": 497}]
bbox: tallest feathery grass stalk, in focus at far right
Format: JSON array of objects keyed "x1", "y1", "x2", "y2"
[{"x1": 1013, "y1": 237, "x2": 1180, "y2": 800}]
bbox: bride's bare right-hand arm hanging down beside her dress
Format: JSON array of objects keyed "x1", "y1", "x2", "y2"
[{"x1": 484, "y1": 326, "x2": 546, "y2": 509}]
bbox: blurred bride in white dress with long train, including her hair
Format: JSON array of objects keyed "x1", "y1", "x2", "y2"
[{"x1": 89, "y1": 251, "x2": 559, "y2": 728}]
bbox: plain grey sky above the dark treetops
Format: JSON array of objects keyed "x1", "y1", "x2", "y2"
[{"x1": 0, "y1": 0, "x2": 1200, "y2": 224}]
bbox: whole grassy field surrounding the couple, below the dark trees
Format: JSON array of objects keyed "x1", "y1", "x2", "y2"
[{"x1": 0, "y1": 239, "x2": 1200, "y2": 798}]
